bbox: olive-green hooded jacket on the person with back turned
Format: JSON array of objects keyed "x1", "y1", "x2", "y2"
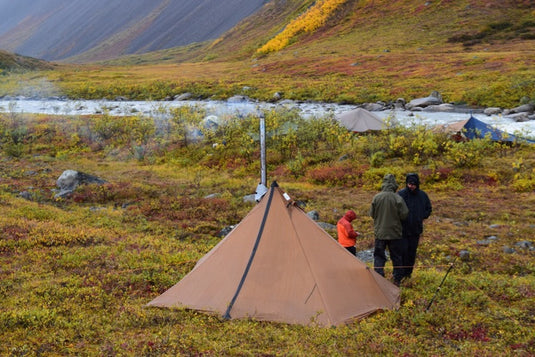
[{"x1": 370, "y1": 174, "x2": 409, "y2": 240}]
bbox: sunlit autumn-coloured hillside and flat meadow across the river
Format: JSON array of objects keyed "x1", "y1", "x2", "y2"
[{"x1": 0, "y1": 0, "x2": 535, "y2": 107}]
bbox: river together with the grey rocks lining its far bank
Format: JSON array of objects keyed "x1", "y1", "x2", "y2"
[{"x1": 0, "y1": 91, "x2": 535, "y2": 136}]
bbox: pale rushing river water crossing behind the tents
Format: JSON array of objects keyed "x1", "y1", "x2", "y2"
[{"x1": 0, "y1": 99, "x2": 535, "y2": 137}]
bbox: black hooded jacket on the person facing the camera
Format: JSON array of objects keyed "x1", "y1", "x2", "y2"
[{"x1": 398, "y1": 173, "x2": 433, "y2": 237}]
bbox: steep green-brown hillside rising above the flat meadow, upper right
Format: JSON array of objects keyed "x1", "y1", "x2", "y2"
[{"x1": 116, "y1": 0, "x2": 535, "y2": 62}]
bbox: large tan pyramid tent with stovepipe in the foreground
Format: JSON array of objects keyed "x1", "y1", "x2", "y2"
[{"x1": 147, "y1": 182, "x2": 400, "y2": 326}]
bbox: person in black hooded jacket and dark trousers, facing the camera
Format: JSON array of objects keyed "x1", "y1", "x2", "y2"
[{"x1": 398, "y1": 173, "x2": 433, "y2": 278}]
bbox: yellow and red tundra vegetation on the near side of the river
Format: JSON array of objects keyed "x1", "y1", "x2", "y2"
[{"x1": 0, "y1": 107, "x2": 535, "y2": 356}]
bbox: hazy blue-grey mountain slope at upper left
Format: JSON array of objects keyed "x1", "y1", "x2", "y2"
[{"x1": 0, "y1": 0, "x2": 268, "y2": 61}]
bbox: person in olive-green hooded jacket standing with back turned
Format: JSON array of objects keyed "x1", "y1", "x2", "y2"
[{"x1": 370, "y1": 174, "x2": 409, "y2": 286}]
